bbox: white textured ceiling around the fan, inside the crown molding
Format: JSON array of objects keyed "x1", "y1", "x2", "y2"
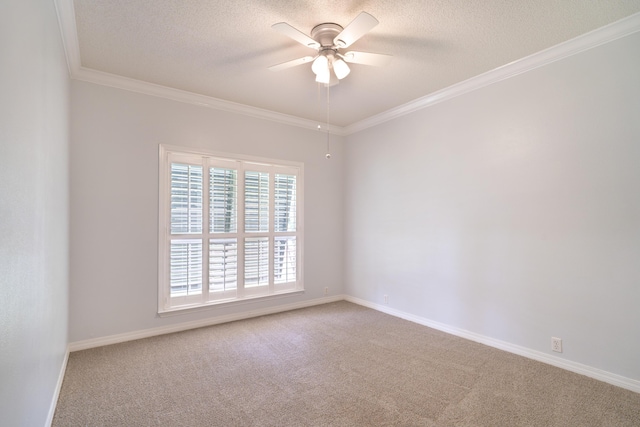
[{"x1": 73, "y1": 0, "x2": 640, "y2": 126}]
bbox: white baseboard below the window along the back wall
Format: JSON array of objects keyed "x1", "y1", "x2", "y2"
[{"x1": 69, "y1": 295, "x2": 345, "y2": 351}]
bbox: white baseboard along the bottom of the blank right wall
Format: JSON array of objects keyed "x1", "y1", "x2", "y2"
[{"x1": 344, "y1": 295, "x2": 640, "y2": 393}]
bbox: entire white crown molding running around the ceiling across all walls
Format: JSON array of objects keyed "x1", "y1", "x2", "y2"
[{"x1": 54, "y1": 0, "x2": 640, "y2": 136}]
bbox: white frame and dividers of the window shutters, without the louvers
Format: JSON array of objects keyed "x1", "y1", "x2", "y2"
[{"x1": 158, "y1": 144, "x2": 304, "y2": 314}]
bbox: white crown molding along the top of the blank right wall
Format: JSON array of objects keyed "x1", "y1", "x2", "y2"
[{"x1": 344, "y1": 13, "x2": 640, "y2": 135}]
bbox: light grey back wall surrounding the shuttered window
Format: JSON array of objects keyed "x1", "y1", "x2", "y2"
[{"x1": 69, "y1": 81, "x2": 343, "y2": 342}]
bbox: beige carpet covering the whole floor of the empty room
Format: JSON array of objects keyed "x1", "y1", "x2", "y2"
[{"x1": 53, "y1": 302, "x2": 640, "y2": 427}]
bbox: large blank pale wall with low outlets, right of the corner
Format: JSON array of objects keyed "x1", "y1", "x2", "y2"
[{"x1": 345, "y1": 33, "x2": 640, "y2": 380}]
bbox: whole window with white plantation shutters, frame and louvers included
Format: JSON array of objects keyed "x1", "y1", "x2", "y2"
[{"x1": 158, "y1": 145, "x2": 303, "y2": 313}]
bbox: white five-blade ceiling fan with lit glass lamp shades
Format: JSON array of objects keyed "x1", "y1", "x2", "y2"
[{"x1": 269, "y1": 12, "x2": 392, "y2": 86}]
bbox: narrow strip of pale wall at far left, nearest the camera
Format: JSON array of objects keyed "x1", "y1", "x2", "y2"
[{"x1": 0, "y1": 0, "x2": 69, "y2": 426}]
